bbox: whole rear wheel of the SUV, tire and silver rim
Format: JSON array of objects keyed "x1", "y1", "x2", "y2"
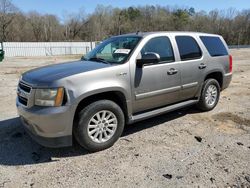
[{"x1": 196, "y1": 79, "x2": 220, "y2": 111}]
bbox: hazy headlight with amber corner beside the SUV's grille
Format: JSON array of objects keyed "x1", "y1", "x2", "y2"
[{"x1": 35, "y1": 88, "x2": 64, "y2": 106}]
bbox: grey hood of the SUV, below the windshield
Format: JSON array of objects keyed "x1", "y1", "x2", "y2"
[{"x1": 22, "y1": 61, "x2": 112, "y2": 85}]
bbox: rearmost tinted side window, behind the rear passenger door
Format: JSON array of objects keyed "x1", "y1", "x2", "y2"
[{"x1": 200, "y1": 36, "x2": 228, "y2": 57}]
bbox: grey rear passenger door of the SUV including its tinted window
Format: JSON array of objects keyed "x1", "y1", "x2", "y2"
[{"x1": 175, "y1": 35, "x2": 207, "y2": 100}]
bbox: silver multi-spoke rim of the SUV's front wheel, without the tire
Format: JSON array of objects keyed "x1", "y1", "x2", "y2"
[{"x1": 88, "y1": 110, "x2": 118, "y2": 143}]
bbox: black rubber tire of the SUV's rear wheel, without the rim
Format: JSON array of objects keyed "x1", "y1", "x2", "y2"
[{"x1": 196, "y1": 78, "x2": 220, "y2": 111}]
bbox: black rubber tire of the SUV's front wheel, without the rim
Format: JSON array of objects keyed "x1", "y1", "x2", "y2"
[{"x1": 73, "y1": 100, "x2": 125, "y2": 152}]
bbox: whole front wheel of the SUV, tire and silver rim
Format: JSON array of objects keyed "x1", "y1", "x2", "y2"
[{"x1": 73, "y1": 100, "x2": 125, "y2": 152}]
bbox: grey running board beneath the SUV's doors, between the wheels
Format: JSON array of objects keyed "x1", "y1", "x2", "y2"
[{"x1": 129, "y1": 100, "x2": 199, "y2": 123}]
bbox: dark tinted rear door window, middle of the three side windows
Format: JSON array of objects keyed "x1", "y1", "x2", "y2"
[{"x1": 175, "y1": 36, "x2": 202, "y2": 61}]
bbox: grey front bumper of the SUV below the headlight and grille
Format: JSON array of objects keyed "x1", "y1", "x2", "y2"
[{"x1": 16, "y1": 100, "x2": 74, "y2": 147}]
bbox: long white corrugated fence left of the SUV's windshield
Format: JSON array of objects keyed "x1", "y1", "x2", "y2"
[{"x1": 3, "y1": 42, "x2": 95, "y2": 57}]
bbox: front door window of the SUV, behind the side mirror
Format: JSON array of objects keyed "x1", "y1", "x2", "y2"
[{"x1": 141, "y1": 37, "x2": 174, "y2": 62}]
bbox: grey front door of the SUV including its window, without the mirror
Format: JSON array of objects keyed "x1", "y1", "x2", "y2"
[{"x1": 133, "y1": 36, "x2": 181, "y2": 113}]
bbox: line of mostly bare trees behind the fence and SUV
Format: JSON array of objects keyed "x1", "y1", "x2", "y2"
[{"x1": 0, "y1": 0, "x2": 250, "y2": 45}]
